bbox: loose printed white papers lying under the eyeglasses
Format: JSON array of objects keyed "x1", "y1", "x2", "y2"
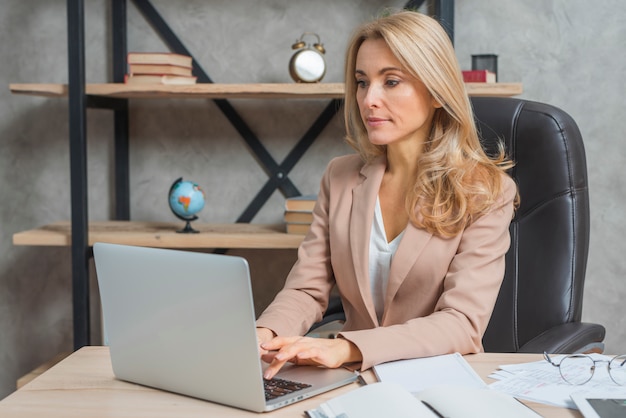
[{"x1": 489, "y1": 354, "x2": 626, "y2": 409}]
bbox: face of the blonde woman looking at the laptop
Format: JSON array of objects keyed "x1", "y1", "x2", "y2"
[{"x1": 354, "y1": 39, "x2": 440, "y2": 150}]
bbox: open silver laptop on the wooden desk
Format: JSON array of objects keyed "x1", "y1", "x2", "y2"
[{"x1": 93, "y1": 243, "x2": 357, "y2": 412}]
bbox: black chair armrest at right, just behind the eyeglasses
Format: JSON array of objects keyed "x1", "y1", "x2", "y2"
[{"x1": 518, "y1": 322, "x2": 606, "y2": 354}]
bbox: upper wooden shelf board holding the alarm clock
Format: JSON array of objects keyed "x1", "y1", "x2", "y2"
[{"x1": 9, "y1": 83, "x2": 523, "y2": 99}]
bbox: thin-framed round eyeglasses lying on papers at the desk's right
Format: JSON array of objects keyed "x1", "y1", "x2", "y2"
[{"x1": 543, "y1": 351, "x2": 626, "y2": 385}]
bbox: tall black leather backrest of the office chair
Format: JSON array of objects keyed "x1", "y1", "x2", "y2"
[{"x1": 472, "y1": 97, "x2": 590, "y2": 352}]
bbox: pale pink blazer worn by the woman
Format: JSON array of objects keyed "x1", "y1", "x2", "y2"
[{"x1": 257, "y1": 155, "x2": 516, "y2": 370}]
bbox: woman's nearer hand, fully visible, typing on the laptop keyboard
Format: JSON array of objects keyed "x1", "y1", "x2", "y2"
[{"x1": 261, "y1": 337, "x2": 362, "y2": 379}]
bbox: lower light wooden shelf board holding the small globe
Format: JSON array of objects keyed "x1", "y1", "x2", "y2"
[{"x1": 13, "y1": 221, "x2": 304, "y2": 249}]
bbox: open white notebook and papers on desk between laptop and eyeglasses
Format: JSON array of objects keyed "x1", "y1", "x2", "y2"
[{"x1": 307, "y1": 353, "x2": 540, "y2": 418}]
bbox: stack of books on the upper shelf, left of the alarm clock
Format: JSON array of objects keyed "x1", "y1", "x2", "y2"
[{"x1": 124, "y1": 52, "x2": 197, "y2": 85}]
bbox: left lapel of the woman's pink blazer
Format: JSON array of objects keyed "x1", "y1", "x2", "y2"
[{"x1": 350, "y1": 157, "x2": 386, "y2": 324}]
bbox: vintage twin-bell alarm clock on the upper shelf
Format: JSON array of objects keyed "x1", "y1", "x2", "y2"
[{"x1": 289, "y1": 32, "x2": 326, "y2": 83}]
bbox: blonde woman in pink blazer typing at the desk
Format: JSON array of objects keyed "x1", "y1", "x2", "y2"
[{"x1": 257, "y1": 12, "x2": 517, "y2": 378}]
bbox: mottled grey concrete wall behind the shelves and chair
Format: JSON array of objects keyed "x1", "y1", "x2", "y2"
[{"x1": 0, "y1": 0, "x2": 626, "y2": 398}]
